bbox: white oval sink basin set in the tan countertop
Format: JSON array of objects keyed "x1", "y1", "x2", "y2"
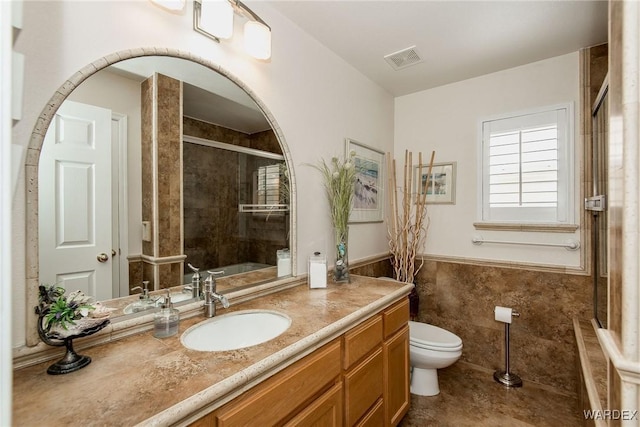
[{"x1": 180, "y1": 310, "x2": 291, "y2": 351}]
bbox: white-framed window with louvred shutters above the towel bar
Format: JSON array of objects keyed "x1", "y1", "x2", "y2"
[{"x1": 480, "y1": 104, "x2": 573, "y2": 224}]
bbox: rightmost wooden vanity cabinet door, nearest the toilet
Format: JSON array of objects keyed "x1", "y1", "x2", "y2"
[{"x1": 383, "y1": 325, "x2": 411, "y2": 426}]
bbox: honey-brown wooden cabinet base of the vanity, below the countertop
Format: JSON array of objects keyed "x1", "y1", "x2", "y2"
[{"x1": 192, "y1": 298, "x2": 409, "y2": 427}]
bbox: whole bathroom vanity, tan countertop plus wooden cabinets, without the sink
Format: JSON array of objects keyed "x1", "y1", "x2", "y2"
[{"x1": 13, "y1": 276, "x2": 412, "y2": 426}]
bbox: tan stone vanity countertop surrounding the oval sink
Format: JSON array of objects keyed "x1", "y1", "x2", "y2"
[{"x1": 13, "y1": 276, "x2": 412, "y2": 426}]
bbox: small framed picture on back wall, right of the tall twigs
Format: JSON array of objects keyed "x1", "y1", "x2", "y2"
[{"x1": 416, "y1": 162, "x2": 456, "y2": 205}]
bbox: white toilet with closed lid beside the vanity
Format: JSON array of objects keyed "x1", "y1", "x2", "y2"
[{"x1": 409, "y1": 321, "x2": 462, "y2": 396}]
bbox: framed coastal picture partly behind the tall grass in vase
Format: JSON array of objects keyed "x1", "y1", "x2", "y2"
[{"x1": 345, "y1": 138, "x2": 385, "y2": 222}]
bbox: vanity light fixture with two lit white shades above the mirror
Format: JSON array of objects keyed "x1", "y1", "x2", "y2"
[{"x1": 193, "y1": 0, "x2": 271, "y2": 60}]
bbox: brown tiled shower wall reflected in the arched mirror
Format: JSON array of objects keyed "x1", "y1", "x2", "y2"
[{"x1": 183, "y1": 117, "x2": 288, "y2": 268}]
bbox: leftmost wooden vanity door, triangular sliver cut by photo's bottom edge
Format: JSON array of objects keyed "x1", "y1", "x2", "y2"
[{"x1": 284, "y1": 383, "x2": 342, "y2": 427}]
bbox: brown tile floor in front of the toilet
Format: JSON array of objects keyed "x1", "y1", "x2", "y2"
[{"x1": 400, "y1": 362, "x2": 582, "y2": 427}]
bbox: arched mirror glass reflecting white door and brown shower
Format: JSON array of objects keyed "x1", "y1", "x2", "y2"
[{"x1": 38, "y1": 56, "x2": 291, "y2": 320}]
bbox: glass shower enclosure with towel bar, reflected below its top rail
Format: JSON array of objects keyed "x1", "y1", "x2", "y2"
[{"x1": 183, "y1": 135, "x2": 289, "y2": 283}]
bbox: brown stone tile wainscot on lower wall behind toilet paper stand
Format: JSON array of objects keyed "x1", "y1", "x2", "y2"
[{"x1": 353, "y1": 259, "x2": 591, "y2": 395}]
